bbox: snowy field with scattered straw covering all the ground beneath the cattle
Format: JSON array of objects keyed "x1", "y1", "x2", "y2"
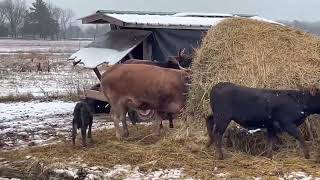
[{"x1": 0, "y1": 40, "x2": 320, "y2": 179}]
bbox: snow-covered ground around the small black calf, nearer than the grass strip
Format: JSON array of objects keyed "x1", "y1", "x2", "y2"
[{"x1": 0, "y1": 101, "x2": 113, "y2": 149}]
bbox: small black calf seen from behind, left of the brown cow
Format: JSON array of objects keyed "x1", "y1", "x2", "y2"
[{"x1": 72, "y1": 102, "x2": 93, "y2": 147}]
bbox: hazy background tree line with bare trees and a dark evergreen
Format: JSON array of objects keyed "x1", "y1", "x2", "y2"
[{"x1": 0, "y1": 0, "x2": 106, "y2": 39}]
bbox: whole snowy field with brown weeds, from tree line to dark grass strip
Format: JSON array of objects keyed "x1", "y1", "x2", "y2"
[{"x1": 0, "y1": 39, "x2": 98, "y2": 97}]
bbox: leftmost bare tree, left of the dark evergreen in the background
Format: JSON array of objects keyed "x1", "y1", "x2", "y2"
[{"x1": 4, "y1": 0, "x2": 27, "y2": 37}]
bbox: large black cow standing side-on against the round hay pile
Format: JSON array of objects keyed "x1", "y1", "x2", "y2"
[{"x1": 207, "y1": 82, "x2": 320, "y2": 159}]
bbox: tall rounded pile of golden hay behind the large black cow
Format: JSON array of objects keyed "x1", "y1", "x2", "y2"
[{"x1": 186, "y1": 18, "x2": 320, "y2": 155}]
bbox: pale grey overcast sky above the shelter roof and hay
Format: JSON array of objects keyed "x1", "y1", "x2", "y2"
[{"x1": 27, "y1": 0, "x2": 320, "y2": 21}]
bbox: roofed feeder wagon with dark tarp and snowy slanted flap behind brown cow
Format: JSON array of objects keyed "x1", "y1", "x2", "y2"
[{"x1": 69, "y1": 10, "x2": 277, "y2": 121}]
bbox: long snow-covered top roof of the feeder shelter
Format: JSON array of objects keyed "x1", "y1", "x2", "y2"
[{"x1": 82, "y1": 11, "x2": 279, "y2": 29}]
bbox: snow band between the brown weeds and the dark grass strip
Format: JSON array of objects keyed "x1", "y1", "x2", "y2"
[{"x1": 0, "y1": 70, "x2": 97, "y2": 97}]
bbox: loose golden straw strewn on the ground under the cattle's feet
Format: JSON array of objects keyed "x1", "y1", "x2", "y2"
[{"x1": 0, "y1": 125, "x2": 320, "y2": 179}]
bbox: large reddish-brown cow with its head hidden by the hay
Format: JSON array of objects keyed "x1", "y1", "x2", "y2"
[{"x1": 101, "y1": 64, "x2": 189, "y2": 139}]
